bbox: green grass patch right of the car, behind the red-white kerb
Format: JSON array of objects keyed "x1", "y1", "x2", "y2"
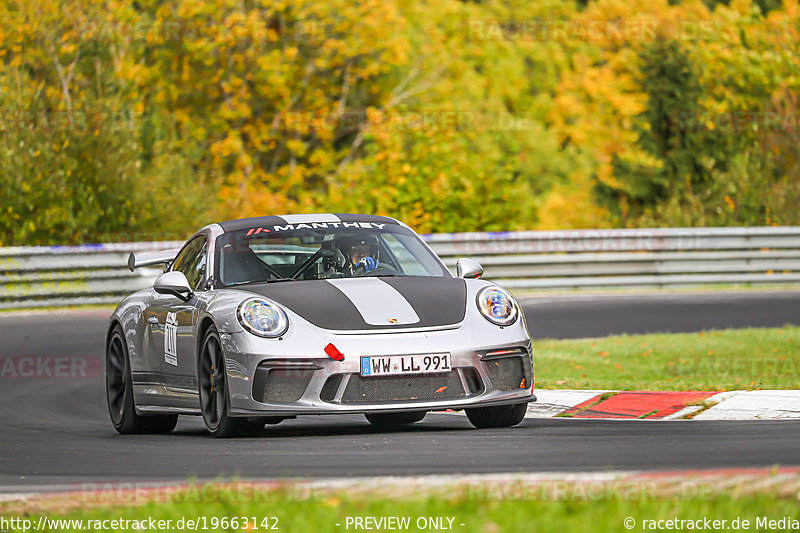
[{"x1": 534, "y1": 326, "x2": 800, "y2": 390}]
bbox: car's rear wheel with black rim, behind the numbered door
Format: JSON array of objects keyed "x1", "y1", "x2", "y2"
[{"x1": 106, "y1": 324, "x2": 178, "y2": 435}]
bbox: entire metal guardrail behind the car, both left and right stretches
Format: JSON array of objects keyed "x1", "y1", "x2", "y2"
[{"x1": 0, "y1": 227, "x2": 800, "y2": 309}]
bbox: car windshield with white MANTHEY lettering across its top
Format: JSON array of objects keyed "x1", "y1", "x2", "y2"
[{"x1": 215, "y1": 222, "x2": 450, "y2": 287}]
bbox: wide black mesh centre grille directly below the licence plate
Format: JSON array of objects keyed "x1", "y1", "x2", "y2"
[{"x1": 342, "y1": 370, "x2": 466, "y2": 403}]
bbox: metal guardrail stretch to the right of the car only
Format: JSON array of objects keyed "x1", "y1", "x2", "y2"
[{"x1": 432, "y1": 226, "x2": 800, "y2": 290}]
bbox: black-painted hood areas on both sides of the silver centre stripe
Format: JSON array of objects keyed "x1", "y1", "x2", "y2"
[{"x1": 244, "y1": 276, "x2": 467, "y2": 331}]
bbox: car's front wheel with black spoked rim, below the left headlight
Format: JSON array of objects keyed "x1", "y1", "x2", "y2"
[{"x1": 197, "y1": 326, "x2": 264, "y2": 438}]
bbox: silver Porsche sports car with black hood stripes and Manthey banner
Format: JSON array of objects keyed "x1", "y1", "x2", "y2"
[{"x1": 106, "y1": 214, "x2": 535, "y2": 437}]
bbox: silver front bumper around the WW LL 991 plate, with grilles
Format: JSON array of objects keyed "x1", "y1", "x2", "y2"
[{"x1": 222, "y1": 327, "x2": 536, "y2": 417}]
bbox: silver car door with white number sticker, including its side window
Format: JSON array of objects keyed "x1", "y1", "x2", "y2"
[{"x1": 146, "y1": 235, "x2": 208, "y2": 406}]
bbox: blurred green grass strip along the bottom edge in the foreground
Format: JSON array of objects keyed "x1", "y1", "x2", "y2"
[{"x1": 4, "y1": 490, "x2": 800, "y2": 533}]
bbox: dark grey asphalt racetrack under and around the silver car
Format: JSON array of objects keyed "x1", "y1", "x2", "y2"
[{"x1": 0, "y1": 291, "x2": 800, "y2": 492}]
